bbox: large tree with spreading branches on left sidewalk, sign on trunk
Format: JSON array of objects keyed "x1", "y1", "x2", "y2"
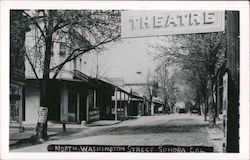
[{"x1": 23, "y1": 10, "x2": 120, "y2": 142}]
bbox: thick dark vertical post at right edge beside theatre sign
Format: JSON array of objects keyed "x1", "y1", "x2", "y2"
[{"x1": 226, "y1": 11, "x2": 239, "y2": 152}]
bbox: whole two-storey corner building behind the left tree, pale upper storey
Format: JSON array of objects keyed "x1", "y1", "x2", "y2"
[{"x1": 23, "y1": 18, "x2": 114, "y2": 123}]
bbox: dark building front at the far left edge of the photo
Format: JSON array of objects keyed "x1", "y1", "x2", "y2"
[{"x1": 10, "y1": 10, "x2": 29, "y2": 132}]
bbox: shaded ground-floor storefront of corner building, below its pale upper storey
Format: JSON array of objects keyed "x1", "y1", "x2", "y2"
[{"x1": 25, "y1": 71, "x2": 114, "y2": 123}]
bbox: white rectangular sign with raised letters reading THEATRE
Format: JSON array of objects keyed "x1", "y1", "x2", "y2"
[{"x1": 121, "y1": 10, "x2": 225, "y2": 38}]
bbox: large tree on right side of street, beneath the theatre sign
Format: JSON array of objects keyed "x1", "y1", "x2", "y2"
[{"x1": 151, "y1": 33, "x2": 226, "y2": 123}]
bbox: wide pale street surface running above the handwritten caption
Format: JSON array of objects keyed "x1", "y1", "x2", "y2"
[{"x1": 13, "y1": 114, "x2": 215, "y2": 152}]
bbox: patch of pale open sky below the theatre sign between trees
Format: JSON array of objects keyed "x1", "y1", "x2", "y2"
[{"x1": 98, "y1": 37, "x2": 160, "y2": 83}]
